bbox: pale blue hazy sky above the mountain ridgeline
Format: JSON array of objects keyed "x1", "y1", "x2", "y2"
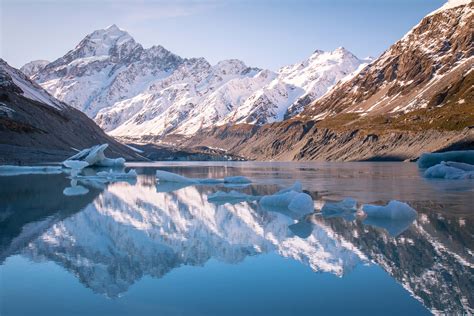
[{"x1": 0, "y1": 0, "x2": 446, "y2": 70}]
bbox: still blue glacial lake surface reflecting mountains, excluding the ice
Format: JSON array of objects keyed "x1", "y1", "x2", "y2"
[{"x1": 0, "y1": 162, "x2": 474, "y2": 316}]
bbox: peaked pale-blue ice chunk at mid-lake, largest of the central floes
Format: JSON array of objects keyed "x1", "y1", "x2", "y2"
[{"x1": 260, "y1": 182, "x2": 314, "y2": 214}]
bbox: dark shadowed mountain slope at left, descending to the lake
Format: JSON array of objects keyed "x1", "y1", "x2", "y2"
[{"x1": 0, "y1": 59, "x2": 139, "y2": 163}]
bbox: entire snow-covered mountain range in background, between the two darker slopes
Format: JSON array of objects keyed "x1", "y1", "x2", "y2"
[{"x1": 25, "y1": 25, "x2": 365, "y2": 138}]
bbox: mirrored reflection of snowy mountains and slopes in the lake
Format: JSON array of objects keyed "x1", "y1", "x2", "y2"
[{"x1": 0, "y1": 163, "x2": 474, "y2": 313}]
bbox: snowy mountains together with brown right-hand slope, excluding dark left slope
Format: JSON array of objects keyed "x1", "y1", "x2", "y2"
[{"x1": 2, "y1": 0, "x2": 474, "y2": 160}]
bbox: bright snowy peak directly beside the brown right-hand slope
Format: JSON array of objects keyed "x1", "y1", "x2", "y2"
[{"x1": 219, "y1": 47, "x2": 371, "y2": 124}]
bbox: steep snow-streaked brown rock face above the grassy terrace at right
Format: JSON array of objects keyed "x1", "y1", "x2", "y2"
[{"x1": 301, "y1": 3, "x2": 474, "y2": 118}]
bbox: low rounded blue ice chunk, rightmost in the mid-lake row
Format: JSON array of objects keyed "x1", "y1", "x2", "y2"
[{"x1": 362, "y1": 200, "x2": 417, "y2": 220}]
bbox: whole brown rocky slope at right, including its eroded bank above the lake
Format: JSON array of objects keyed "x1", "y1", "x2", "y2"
[{"x1": 183, "y1": 0, "x2": 474, "y2": 160}]
